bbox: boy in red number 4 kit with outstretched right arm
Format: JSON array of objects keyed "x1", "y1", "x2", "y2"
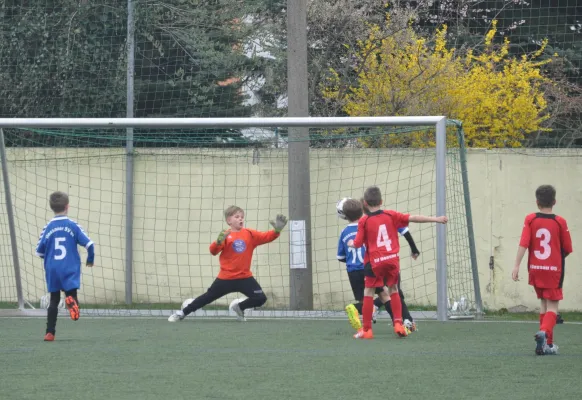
[{"x1": 348, "y1": 186, "x2": 448, "y2": 339}]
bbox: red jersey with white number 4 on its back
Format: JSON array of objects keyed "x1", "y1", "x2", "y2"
[{"x1": 354, "y1": 210, "x2": 410, "y2": 267}]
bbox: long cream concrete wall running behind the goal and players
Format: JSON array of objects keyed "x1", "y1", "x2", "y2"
[{"x1": 0, "y1": 149, "x2": 582, "y2": 309}]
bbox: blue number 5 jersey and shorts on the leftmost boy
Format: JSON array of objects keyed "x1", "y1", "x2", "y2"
[{"x1": 36, "y1": 216, "x2": 94, "y2": 292}]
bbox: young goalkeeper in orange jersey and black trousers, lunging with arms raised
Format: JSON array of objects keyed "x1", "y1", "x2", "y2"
[{"x1": 168, "y1": 206, "x2": 287, "y2": 322}]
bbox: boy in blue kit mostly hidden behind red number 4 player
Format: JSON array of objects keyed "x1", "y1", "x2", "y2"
[{"x1": 337, "y1": 199, "x2": 420, "y2": 332}]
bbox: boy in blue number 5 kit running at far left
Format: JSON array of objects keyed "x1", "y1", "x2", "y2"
[{"x1": 36, "y1": 192, "x2": 95, "y2": 342}]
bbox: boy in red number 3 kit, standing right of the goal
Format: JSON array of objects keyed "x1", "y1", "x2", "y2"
[{"x1": 511, "y1": 185, "x2": 572, "y2": 356}]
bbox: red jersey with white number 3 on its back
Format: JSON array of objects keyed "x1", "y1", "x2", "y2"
[{"x1": 519, "y1": 213, "x2": 572, "y2": 289}]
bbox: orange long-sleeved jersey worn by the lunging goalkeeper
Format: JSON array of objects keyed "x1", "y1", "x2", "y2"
[{"x1": 210, "y1": 228, "x2": 279, "y2": 280}]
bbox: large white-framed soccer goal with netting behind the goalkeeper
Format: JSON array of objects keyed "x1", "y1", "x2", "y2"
[{"x1": 0, "y1": 117, "x2": 482, "y2": 320}]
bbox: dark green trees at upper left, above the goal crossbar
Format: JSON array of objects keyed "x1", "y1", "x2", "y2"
[{"x1": 0, "y1": 0, "x2": 276, "y2": 146}]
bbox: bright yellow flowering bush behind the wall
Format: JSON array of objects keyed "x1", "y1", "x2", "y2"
[{"x1": 324, "y1": 19, "x2": 549, "y2": 148}]
